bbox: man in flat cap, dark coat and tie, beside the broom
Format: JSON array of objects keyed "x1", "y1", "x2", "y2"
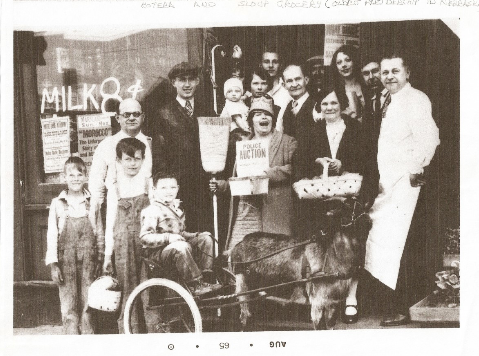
[{"x1": 153, "y1": 62, "x2": 213, "y2": 231}]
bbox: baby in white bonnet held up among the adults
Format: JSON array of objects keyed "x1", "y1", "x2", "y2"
[{"x1": 221, "y1": 78, "x2": 250, "y2": 133}]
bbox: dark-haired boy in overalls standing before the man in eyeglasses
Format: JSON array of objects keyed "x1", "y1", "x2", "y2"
[{"x1": 103, "y1": 137, "x2": 151, "y2": 333}]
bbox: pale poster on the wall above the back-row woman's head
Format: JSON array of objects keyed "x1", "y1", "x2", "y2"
[{"x1": 324, "y1": 24, "x2": 359, "y2": 66}]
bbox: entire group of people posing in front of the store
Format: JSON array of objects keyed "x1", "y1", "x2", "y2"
[{"x1": 46, "y1": 45, "x2": 439, "y2": 333}]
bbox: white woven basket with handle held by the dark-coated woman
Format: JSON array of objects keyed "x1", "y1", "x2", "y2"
[{"x1": 293, "y1": 164, "x2": 363, "y2": 199}]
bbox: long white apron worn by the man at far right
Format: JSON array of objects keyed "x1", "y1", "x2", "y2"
[{"x1": 364, "y1": 90, "x2": 421, "y2": 289}]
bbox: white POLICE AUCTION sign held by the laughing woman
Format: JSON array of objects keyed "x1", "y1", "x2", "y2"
[{"x1": 236, "y1": 140, "x2": 269, "y2": 177}]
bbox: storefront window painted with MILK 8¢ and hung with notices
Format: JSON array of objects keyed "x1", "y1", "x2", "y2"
[{"x1": 36, "y1": 29, "x2": 188, "y2": 183}]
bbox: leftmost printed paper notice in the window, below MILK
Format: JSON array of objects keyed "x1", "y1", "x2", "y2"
[{"x1": 40, "y1": 116, "x2": 70, "y2": 173}]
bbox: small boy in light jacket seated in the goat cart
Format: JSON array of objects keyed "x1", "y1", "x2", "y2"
[{"x1": 140, "y1": 172, "x2": 221, "y2": 295}]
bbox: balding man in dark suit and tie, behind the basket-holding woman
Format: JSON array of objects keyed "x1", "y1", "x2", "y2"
[{"x1": 283, "y1": 65, "x2": 315, "y2": 141}]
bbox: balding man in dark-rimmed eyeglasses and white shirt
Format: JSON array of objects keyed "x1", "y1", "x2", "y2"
[{"x1": 88, "y1": 98, "x2": 152, "y2": 216}]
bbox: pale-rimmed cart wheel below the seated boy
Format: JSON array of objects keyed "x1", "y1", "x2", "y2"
[{"x1": 123, "y1": 278, "x2": 203, "y2": 334}]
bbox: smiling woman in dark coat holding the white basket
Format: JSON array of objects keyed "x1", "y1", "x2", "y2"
[{"x1": 293, "y1": 91, "x2": 366, "y2": 323}]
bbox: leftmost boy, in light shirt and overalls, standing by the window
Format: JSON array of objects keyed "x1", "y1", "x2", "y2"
[{"x1": 45, "y1": 157, "x2": 104, "y2": 334}]
